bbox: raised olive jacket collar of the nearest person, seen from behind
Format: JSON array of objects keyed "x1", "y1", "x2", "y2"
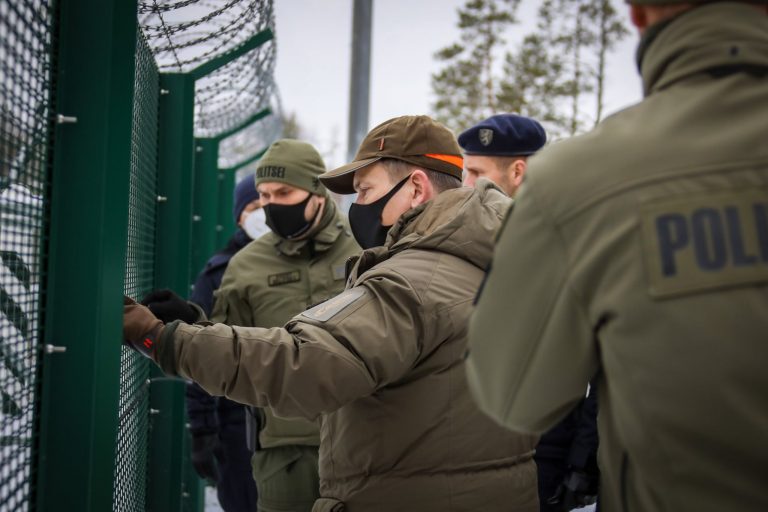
[{"x1": 638, "y1": 2, "x2": 768, "y2": 96}]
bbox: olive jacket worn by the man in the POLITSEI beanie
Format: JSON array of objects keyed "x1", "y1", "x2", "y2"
[{"x1": 211, "y1": 199, "x2": 360, "y2": 448}]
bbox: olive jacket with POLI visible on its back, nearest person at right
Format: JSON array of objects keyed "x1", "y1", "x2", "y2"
[{"x1": 467, "y1": 2, "x2": 768, "y2": 512}]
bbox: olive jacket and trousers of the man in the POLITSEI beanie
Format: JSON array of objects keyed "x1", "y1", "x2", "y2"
[{"x1": 211, "y1": 195, "x2": 360, "y2": 511}]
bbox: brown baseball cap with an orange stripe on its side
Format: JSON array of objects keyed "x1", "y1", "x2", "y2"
[{"x1": 320, "y1": 116, "x2": 464, "y2": 194}]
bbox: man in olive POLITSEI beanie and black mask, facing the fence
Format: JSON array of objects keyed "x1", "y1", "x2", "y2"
[{"x1": 210, "y1": 139, "x2": 360, "y2": 512}]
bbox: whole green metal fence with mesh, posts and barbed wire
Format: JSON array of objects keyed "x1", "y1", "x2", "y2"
[{"x1": 0, "y1": 0, "x2": 280, "y2": 512}]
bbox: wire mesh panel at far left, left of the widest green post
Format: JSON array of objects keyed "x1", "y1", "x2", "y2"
[{"x1": 0, "y1": 0, "x2": 52, "y2": 512}]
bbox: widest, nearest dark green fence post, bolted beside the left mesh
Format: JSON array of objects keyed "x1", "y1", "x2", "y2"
[{"x1": 35, "y1": 0, "x2": 136, "y2": 512}]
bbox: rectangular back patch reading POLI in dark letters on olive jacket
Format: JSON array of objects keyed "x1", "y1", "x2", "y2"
[{"x1": 641, "y1": 189, "x2": 768, "y2": 297}]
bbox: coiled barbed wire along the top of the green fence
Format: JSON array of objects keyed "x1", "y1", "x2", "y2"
[{"x1": 139, "y1": 0, "x2": 275, "y2": 137}]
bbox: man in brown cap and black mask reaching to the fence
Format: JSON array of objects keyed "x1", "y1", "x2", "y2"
[{"x1": 124, "y1": 116, "x2": 538, "y2": 512}]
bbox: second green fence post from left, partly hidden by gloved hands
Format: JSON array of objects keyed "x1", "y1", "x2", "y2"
[{"x1": 147, "y1": 73, "x2": 199, "y2": 512}]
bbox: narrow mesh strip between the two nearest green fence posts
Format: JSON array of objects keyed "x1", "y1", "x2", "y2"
[{"x1": 113, "y1": 32, "x2": 160, "y2": 512}]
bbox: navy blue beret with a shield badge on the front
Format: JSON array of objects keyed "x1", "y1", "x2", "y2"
[{"x1": 459, "y1": 114, "x2": 547, "y2": 156}]
